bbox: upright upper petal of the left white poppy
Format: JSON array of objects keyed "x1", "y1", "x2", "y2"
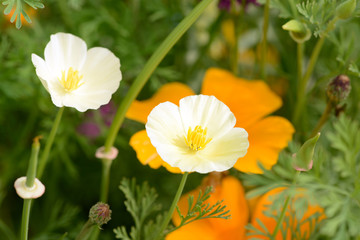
[{"x1": 44, "y1": 33, "x2": 87, "y2": 78}]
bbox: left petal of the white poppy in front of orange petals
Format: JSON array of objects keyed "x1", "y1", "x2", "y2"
[{"x1": 145, "y1": 102, "x2": 190, "y2": 166}]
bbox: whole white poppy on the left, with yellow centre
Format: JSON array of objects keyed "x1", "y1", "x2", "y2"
[{"x1": 31, "y1": 33, "x2": 122, "y2": 112}]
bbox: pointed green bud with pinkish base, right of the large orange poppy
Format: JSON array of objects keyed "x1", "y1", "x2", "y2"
[{"x1": 293, "y1": 133, "x2": 320, "y2": 171}]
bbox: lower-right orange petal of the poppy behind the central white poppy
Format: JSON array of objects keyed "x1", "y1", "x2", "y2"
[{"x1": 234, "y1": 116, "x2": 295, "y2": 173}]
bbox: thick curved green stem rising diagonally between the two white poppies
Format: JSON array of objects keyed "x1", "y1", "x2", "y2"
[{"x1": 105, "y1": 0, "x2": 213, "y2": 152}]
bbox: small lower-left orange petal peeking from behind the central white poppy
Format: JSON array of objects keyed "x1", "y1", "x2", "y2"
[{"x1": 130, "y1": 130, "x2": 181, "y2": 173}]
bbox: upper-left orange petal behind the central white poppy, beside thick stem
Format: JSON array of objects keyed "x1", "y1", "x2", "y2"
[{"x1": 126, "y1": 82, "x2": 194, "y2": 123}]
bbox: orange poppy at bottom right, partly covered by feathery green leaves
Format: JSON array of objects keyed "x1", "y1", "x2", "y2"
[{"x1": 248, "y1": 188, "x2": 325, "y2": 240}]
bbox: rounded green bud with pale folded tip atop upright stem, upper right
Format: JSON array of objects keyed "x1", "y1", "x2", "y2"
[{"x1": 282, "y1": 19, "x2": 311, "y2": 43}]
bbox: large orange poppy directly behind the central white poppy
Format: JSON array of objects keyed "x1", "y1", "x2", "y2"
[{"x1": 126, "y1": 68, "x2": 295, "y2": 173}]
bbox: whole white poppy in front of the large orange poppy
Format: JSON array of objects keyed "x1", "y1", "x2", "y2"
[{"x1": 146, "y1": 95, "x2": 249, "y2": 173}]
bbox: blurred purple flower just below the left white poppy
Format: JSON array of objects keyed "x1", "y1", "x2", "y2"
[{"x1": 77, "y1": 101, "x2": 116, "y2": 140}]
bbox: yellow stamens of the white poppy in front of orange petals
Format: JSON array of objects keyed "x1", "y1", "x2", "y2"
[{"x1": 184, "y1": 125, "x2": 211, "y2": 151}]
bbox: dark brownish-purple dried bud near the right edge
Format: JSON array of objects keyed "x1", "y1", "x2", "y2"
[{"x1": 326, "y1": 75, "x2": 351, "y2": 103}]
